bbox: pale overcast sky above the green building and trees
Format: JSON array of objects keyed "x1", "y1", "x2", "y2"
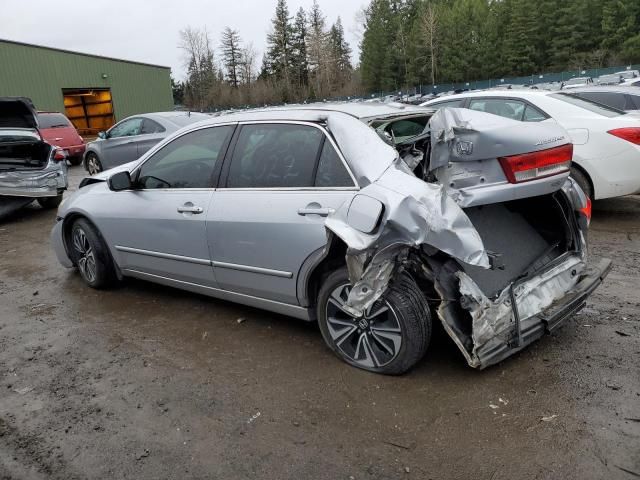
[{"x1": 0, "y1": 0, "x2": 368, "y2": 79}]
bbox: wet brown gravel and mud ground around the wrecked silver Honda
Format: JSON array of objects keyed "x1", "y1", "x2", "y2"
[{"x1": 0, "y1": 167, "x2": 640, "y2": 480}]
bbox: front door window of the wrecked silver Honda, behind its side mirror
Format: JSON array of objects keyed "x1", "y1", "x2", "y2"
[{"x1": 138, "y1": 126, "x2": 233, "y2": 189}]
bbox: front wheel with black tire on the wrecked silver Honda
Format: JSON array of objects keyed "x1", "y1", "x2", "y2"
[{"x1": 67, "y1": 218, "x2": 116, "y2": 289}]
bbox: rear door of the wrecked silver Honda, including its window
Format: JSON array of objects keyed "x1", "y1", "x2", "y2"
[{"x1": 207, "y1": 122, "x2": 357, "y2": 305}]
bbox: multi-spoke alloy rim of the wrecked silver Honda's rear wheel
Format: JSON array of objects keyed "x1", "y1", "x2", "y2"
[{"x1": 326, "y1": 284, "x2": 402, "y2": 368}]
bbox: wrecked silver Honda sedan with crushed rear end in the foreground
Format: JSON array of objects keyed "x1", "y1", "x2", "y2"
[{"x1": 52, "y1": 103, "x2": 610, "y2": 374}]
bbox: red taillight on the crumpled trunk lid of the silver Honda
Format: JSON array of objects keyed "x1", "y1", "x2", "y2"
[{"x1": 498, "y1": 143, "x2": 573, "y2": 183}]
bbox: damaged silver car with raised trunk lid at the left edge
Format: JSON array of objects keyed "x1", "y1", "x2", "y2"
[{"x1": 0, "y1": 97, "x2": 67, "y2": 218}]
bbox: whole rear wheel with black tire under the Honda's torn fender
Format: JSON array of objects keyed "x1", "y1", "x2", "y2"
[{"x1": 317, "y1": 268, "x2": 432, "y2": 375}]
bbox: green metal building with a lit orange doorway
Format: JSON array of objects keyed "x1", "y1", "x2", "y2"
[{"x1": 0, "y1": 39, "x2": 173, "y2": 134}]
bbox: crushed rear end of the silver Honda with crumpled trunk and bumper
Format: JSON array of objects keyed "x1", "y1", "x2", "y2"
[{"x1": 326, "y1": 109, "x2": 611, "y2": 368}]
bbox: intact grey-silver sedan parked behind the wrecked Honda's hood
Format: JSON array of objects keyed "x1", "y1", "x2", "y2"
[{"x1": 83, "y1": 112, "x2": 209, "y2": 175}]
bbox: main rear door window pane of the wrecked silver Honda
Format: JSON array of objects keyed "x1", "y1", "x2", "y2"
[{"x1": 227, "y1": 124, "x2": 324, "y2": 188}]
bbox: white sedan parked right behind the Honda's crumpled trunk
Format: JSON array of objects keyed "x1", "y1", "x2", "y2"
[{"x1": 422, "y1": 90, "x2": 640, "y2": 199}]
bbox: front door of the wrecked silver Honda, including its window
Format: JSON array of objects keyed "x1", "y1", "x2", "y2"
[{"x1": 99, "y1": 125, "x2": 234, "y2": 287}]
